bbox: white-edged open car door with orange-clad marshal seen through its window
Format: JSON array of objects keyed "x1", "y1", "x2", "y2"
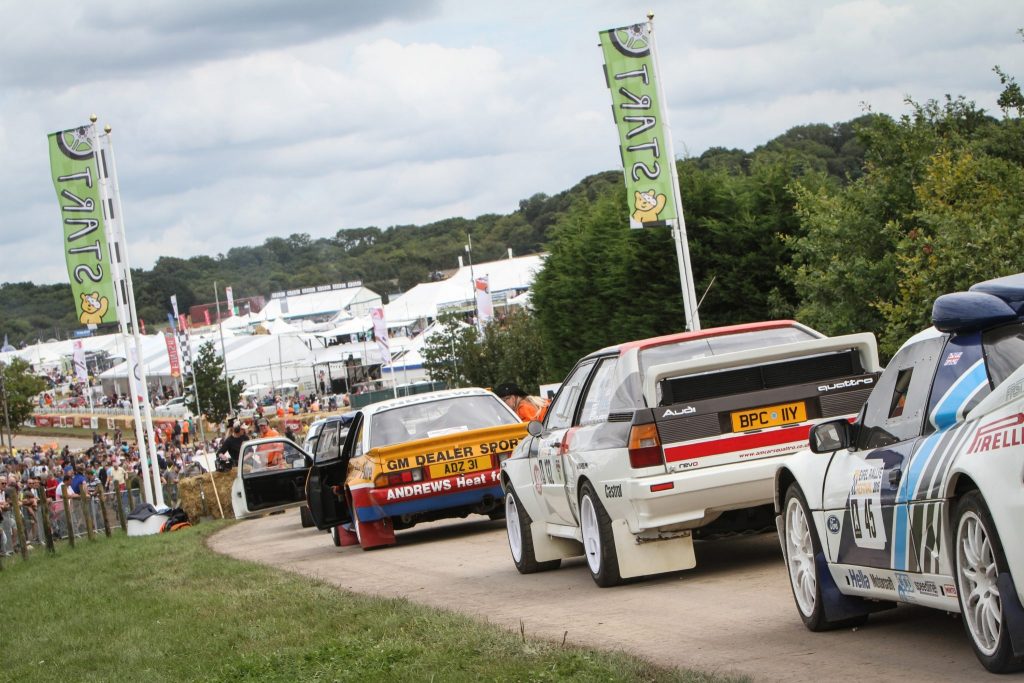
[{"x1": 231, "y1": 437, "x2": 312, "y2": 519}]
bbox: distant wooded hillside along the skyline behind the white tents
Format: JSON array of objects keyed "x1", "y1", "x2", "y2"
[{"x1": 0, "y1": 121, "x2": 863, "y2": 346}]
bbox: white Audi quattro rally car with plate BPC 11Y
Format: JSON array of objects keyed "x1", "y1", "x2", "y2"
[{"x1": 501, "y1": 321, "x2": 880, "y2": 587}]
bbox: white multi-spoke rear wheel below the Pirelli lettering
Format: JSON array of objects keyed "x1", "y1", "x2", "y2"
[{"x1": 952, "y1": 490, "x2": 1024, "y2": 674}]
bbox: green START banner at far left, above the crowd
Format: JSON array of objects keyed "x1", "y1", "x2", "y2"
[{"x1": 48, "y1": 124, "x2": 118, "y2": 327}]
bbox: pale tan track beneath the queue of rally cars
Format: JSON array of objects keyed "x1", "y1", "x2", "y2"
[{"x1": 210, "y1": 511, "x2": 999, "y2": 682}]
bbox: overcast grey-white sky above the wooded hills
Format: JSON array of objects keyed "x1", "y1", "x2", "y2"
[{"x1": 0, "y1": 0, "x2": 1024, "y2": 285}]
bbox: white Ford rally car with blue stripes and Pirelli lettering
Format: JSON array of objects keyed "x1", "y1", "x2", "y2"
[{"x1": 776, "y1": 273, "x2": 1024, "y2": 672}]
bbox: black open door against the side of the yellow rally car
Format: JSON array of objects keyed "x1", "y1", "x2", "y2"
[{"x1": 306, "y1": 413, "x2": 362, "y2": 530}]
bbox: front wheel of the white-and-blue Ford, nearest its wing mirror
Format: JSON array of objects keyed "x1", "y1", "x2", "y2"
[{"x1": 781, "y1": 483, "x2": 867, "y2": 631}]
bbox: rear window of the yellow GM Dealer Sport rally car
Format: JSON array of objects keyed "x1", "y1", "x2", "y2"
[{"x1": 370, "y1": 395, "x2": 519, "y2": 449}]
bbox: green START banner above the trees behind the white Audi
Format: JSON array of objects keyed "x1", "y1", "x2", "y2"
[{"x1": 600, "y1": 24, "x2": 678, "y2": 228}]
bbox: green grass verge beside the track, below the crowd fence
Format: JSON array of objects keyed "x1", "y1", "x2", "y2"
[{"x1": 0, "y1": 522, "x2": 749, "y2": 683}]
